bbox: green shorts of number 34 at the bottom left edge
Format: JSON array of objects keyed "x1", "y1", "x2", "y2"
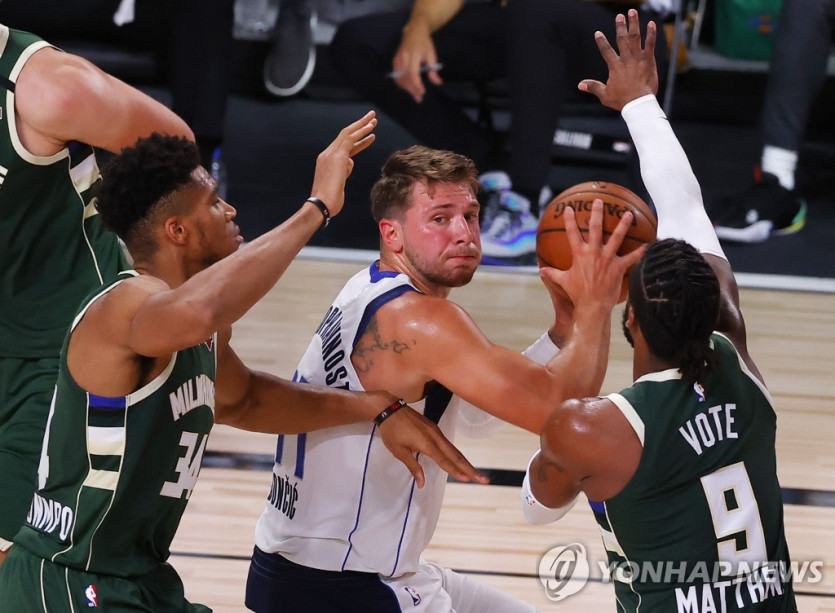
[{"x1": 0, "y1": 545, "x2": 211, "y2": 613}]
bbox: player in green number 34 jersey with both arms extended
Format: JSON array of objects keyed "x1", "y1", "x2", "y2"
[{"x1": 0, "y1": 112, "x2": 483, "y2": 613}]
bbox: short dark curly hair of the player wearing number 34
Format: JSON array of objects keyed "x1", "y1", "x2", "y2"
[{"x1": 95, "y1": 132, "x2": 200, "y2": 254}]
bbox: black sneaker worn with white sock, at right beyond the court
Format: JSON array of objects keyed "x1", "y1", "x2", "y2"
[{"x1": 713, "y1": 172, "x2": 806, "y2": 243}]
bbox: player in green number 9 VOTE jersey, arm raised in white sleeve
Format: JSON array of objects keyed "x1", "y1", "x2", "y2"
[{"x1": 523, "y1": 10, "x2": 797, "y2": 612}]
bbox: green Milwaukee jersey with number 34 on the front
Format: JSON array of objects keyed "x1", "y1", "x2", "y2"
[{"x1": 15, "y1": 271, "x2": 216, "y2": 577}]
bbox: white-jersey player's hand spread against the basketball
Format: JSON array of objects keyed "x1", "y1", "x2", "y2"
[{"x1": 539, "y1": 198, "x2": 645, "y2": 309}]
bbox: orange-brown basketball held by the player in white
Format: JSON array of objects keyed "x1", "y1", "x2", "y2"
[{"x1": 536, "y1": 181, "x2": 658, "y2": 300}]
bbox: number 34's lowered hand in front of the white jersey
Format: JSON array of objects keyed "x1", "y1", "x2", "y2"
[{"x1": 380, "y1": 406, "x2": 488, "y2": 487}]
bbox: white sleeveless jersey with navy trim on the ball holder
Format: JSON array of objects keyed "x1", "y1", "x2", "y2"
[{"x1": 255, "y1": 263, "x2": 455, "y2": 576}]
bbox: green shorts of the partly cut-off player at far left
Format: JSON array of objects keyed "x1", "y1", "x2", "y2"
[{"x1": 0, "y1": 356, "x2": 58, "y2": 541}]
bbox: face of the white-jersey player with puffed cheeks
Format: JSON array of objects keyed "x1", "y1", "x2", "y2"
[{"x1": 402, "y1": 183, "x2": 481, "y2": 288}]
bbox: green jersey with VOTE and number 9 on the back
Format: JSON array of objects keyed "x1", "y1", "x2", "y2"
[{"x1": 591, "y1": 333, "x2": 797, "y2": 613}]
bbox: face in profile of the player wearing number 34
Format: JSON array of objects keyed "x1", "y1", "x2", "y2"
[{"x1": 190, "y1": 166, "x2": 244, "y2": 266}]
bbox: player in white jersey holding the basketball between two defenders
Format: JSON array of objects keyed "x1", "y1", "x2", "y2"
[{"x1": 246, "y1": 140, "x2": 640, "y2": 613}]
